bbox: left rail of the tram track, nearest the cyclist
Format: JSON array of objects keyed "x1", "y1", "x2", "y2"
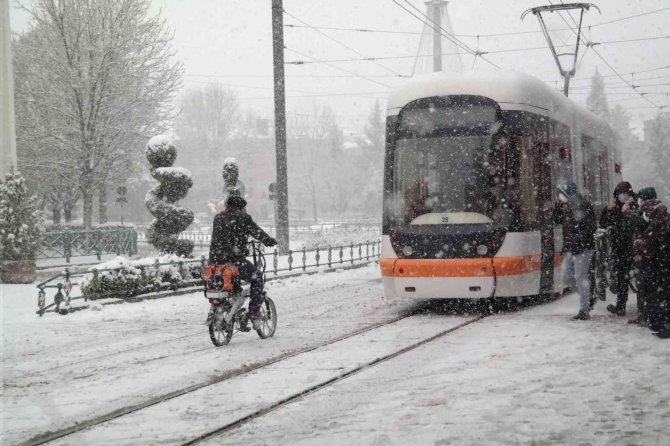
[{"x1": 18, "y1": 309, "x2": 434, "y2": 446}]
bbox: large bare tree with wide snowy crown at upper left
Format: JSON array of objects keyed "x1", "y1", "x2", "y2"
[{"x1": 14, "y1": 0, "x2": 183, "y2": 228}]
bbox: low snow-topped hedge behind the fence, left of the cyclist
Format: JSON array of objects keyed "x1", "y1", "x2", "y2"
[{"x1": 79, "y1": 254, "x2": 202, "y2": 299}]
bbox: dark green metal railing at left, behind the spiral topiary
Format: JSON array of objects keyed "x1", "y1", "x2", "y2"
[{"x1": 37, "y1": 227, "x2": 137, "y2": 263}]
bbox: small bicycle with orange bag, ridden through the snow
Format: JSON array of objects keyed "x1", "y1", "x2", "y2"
[{"x1": 204, "y1": 242, "x2": 277, "y2": 347}]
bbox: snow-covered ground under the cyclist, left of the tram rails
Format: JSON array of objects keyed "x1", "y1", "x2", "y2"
[{"x1": 0, "y1": 265, "x2": 412, "y2": 444}]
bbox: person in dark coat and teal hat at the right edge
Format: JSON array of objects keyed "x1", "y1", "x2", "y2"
[{"x1": 633, "y1": 198, "x2": 670, "y2": 337}]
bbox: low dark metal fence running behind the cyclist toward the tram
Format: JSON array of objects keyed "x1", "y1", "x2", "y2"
[{"x1": 37, "y1": 240, "x2": 381, "y2": 316}]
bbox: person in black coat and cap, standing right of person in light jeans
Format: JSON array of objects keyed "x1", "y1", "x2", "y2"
[{"x1": 600, "y1": 181, "x2": 635, "y2": 316}]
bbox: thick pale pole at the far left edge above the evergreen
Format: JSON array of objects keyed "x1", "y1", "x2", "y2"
[{"x1": 0, "y1": 0, "x2": 17, "y2": 179}]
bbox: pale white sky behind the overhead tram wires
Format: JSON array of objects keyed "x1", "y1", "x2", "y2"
[{"x1": 12, "y1": 0, "x2": 670, "y2": 135}]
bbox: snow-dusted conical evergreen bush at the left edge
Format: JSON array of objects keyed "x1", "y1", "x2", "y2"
[{"x1": 0, "y1": 170, "x2": 44, "y2": 261}]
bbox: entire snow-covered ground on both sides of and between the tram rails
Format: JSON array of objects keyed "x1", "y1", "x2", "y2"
[{"x1": 0, "y1": 265, "x2": 670, "y2": 445}]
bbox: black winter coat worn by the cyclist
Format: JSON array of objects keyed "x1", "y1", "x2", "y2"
[{"x1": 209, "y1": 209, "x2": 274, "y2": 265}]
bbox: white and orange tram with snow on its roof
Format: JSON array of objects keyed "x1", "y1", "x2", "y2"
[{"x1": 380, "y1": 71, "x2": 621, "y2": 299}]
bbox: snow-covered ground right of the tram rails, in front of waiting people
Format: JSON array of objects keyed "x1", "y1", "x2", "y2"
[{"x1": 220, "y1": 295, "x2": 670, "y2": 445}]
